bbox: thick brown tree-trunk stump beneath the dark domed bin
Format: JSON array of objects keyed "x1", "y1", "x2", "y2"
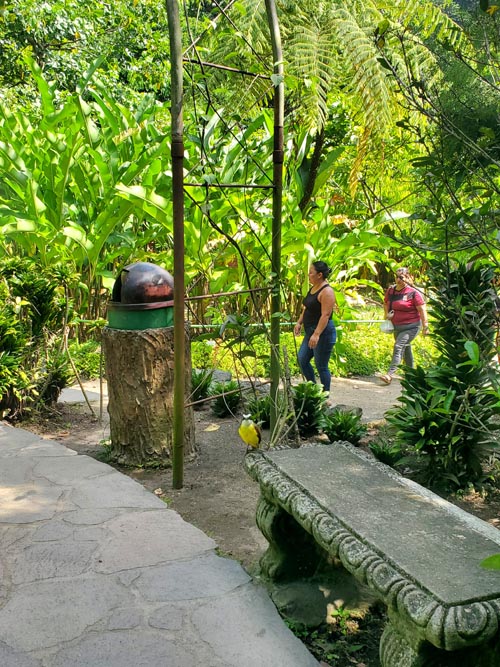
[{"x1": 102, "y1": 327, "x2": 196, "y2": 466}]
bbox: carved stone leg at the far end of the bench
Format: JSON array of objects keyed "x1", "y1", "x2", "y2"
[{"x1": 256, "y1": 495, "x2": 321, "y2": 581}]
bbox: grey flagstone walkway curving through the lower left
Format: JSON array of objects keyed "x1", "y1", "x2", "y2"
[{"x1": 0, "y1": 423, "x2": 318, "y2": 667}]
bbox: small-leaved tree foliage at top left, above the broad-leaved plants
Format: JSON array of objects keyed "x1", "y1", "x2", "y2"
[{"x1": 0, "y1": 0, "x2": 169, "y2": 106}]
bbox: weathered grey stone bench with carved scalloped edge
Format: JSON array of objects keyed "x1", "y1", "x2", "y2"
[{"x1": 245, "y1": 443, "x2": 500, "y2": 667}]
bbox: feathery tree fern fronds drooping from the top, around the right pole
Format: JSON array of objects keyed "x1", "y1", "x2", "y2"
[{"x1": 179, "y1": 0, "x2": 465, "y2": 197}]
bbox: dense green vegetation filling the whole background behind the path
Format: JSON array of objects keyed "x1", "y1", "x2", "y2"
[{"x1": 0, "y1": 0, "x2": 500, "y2": 484}]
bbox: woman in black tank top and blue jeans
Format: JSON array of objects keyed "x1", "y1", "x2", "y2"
[{"x1": 294, "y1": 262, "x2": 337, "y2": 392}]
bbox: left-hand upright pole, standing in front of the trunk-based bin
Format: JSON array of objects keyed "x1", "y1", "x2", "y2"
[{"x1": 166, "y1": 0, "x2": 186, "y2": 489}]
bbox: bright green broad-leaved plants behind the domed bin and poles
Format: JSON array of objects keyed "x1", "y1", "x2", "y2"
[{"x1": 0, "y1": 60, "x2": 414, "y2": 340}]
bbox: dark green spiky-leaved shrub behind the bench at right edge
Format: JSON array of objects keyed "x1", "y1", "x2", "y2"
[{"x1": 387, "y1": 263, "x2": 500, "y2": 489}]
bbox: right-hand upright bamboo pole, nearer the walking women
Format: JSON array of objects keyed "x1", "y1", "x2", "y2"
[{"x1": 266, "y1": 0, "x2": 285, "y2": 433}]
